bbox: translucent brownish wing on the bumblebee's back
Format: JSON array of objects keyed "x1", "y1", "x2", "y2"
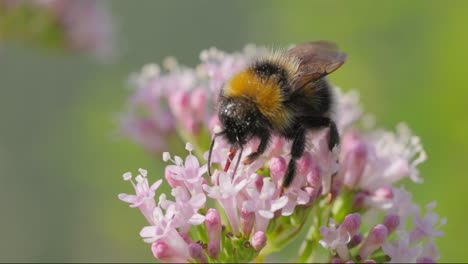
[{"x1": 287, "y1": 41, "x2": 346, "y2": 89}]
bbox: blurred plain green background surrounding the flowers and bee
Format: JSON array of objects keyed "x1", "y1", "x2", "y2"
[{"x1": 0, "y1": 0, "x2": 468, "y2": 262}]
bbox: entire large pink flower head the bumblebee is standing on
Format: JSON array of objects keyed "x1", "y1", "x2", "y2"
[{"x1": 119, "y1": 47, "x2": 446, "y2": 263}]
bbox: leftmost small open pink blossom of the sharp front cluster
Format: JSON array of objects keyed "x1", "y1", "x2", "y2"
[{"x1": 119, "y1": 169, "x2": 162, "y2": 224}]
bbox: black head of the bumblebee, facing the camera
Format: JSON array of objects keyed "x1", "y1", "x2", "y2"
[{"x1": 218, "y1": 97, "x2": 261, "y2": 148}]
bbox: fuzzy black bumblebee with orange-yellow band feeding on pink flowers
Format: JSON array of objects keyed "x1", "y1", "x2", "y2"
[{"x1": 208, "y1": 41, "x2": 346, "y2": 188}]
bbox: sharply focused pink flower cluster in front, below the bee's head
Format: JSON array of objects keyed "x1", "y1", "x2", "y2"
[{"x1": 119, "y1": 143, "x2": 282, "y2": 262}]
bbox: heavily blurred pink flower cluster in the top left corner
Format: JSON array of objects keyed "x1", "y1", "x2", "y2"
[{"x1": 0, "y1": 0, "x2": 113, "y2": 58}]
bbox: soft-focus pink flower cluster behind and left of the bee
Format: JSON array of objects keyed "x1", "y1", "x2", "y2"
[{"x1": 121, "y1": 46, "x2": 264, "y2": 153}]
